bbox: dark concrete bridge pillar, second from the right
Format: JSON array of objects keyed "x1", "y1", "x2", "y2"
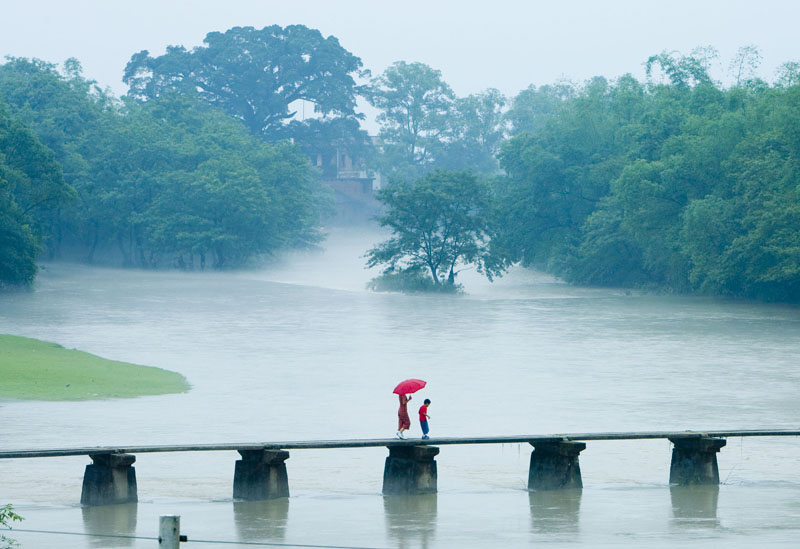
[{"x1": 528, "y1": 440, "x2": 586, "y2": 490}]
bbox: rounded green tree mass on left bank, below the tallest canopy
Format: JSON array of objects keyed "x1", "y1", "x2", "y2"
[{"x1": 0, "y1": 59, "x2": 324, "y2": 268}]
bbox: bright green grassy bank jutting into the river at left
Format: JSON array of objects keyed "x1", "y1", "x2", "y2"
[{"x1": 0, "y1": 335, "x2": 189, "y2": 400}]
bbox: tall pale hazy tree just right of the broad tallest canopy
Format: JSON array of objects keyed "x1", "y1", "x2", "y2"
[{"x1": 367, "y1": 61, "x2": 455, "y2": 180}]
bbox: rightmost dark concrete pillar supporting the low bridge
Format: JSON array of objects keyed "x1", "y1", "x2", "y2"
[{"x1": 669, "y1": 437, "x2": 727, "y2": 486}]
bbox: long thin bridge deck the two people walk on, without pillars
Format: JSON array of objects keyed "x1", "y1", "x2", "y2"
[{"x1": 0, "y1": 429, "x2": 800, "y2": 459}]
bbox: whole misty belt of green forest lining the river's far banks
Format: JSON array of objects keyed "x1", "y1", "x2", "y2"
[{"x1": 0, "y1": 25, "x2": 800, "y2": 302}]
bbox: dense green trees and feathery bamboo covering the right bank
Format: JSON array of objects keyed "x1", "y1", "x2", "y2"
[{"x1": 497, "y1": 47, "x2": 800, "y2": 301}]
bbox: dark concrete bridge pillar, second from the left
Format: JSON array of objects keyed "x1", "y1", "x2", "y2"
[{"x1": 233, "y1": 450, "x2": 289, "y2": 501}]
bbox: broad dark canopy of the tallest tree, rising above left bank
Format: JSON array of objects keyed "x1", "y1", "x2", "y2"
[{"x1": 123, "y1": 25, "x2": 363, "y2": 140}]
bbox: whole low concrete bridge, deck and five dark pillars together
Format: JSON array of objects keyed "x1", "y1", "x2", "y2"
[{"x1": 0, "y1": 429, "x2": 800, "y2": 505}]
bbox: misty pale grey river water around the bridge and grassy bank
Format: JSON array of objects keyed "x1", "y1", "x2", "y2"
[{"x1": 0, "y1": 230, "x2": 800, "y2": 548}]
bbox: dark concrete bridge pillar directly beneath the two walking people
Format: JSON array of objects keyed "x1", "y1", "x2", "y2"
[{"x1": 383, "y1": 446, "x2": 439, "y2": 496}]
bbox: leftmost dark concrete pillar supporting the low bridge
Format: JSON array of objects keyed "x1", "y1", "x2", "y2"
[{"x1": 81, "y1": 454, "x2": 139, "y2": 505}]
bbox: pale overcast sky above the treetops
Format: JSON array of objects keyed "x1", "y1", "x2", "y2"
[{"x1": 0, "y1": 0, "x2": 800, "y2": 131}]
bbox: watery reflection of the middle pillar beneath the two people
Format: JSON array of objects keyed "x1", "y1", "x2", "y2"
[{"x1": 383, "y1": 494, "x2": 437, "y2": 548}]
